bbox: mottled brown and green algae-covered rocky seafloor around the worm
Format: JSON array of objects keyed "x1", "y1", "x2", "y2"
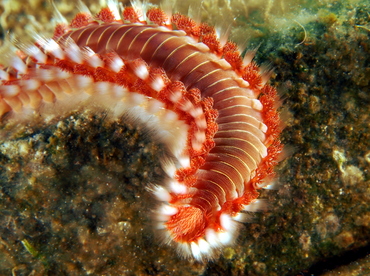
[{"x1": 0, "y1": 0, "x2": 370, "y2": 276}]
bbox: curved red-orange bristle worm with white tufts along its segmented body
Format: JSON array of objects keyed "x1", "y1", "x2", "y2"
[{"x1": 0, "y1": 4, "x2": 281, "y2": 259}]
